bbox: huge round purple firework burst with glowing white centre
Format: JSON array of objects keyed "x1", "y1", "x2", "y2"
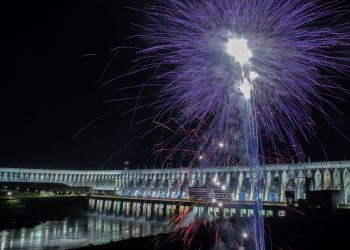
[{"x1": 130, "y1": 0, "x2": 348, "y2": 165}]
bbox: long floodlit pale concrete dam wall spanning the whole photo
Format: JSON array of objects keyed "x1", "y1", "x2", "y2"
[{"x1": 0, "y1": 161, "x2": 350, "y2": 204}]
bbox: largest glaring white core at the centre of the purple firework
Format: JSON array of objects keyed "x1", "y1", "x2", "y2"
[{"x1": 226, "y1": 37, "x2": 253, "y2": 65}]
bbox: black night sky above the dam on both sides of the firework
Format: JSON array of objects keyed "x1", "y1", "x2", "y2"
[{"x1": 0, "y1": 0, "x2": 350, "y2": 169}]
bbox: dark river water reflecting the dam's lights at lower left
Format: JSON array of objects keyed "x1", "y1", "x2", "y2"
[{"x1": 0, "y1": 215, "x2": 171, "y2": 250}]
